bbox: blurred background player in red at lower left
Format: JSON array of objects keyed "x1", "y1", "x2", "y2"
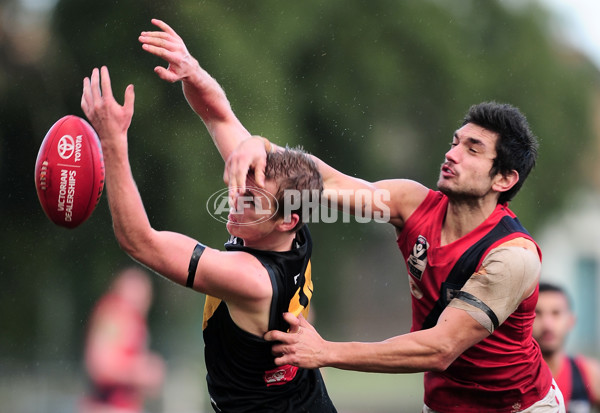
[{"x1": 80, "y1": 267, "x2": 165, "y2": 413}]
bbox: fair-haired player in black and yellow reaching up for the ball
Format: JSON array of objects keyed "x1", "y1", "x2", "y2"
[{"x1": 81, "y1": 20, "x2": 336, "y2": 413}]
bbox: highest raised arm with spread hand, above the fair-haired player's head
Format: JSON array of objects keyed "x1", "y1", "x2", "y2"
[{"x1": 139, "y1": 19, "x2": 250, "y2": 160}]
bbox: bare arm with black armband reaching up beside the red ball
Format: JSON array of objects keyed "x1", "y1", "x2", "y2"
[{"x1": 81, "y1": 67, "x2": 272, "y2": 305}]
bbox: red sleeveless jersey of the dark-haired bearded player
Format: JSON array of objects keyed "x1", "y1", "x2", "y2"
[{"x1": 397, "y1": 191, "x2": 552, "y2": 413}]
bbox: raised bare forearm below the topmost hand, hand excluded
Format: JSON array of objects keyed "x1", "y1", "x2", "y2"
[{"x1": 183, "y1": 65, "x2": 250, "y2": 160}]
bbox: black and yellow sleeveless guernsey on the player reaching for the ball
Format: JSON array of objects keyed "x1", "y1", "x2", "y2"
[{"x1": 203, "y1": 225, "x2": 336, "y2": 413}]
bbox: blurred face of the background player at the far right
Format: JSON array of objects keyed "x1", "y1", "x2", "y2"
[{"x1": 533, "y1": 291, "x2": 575, "y2": 355}]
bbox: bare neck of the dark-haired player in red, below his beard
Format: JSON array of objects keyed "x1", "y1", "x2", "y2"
[{"x1": 441, "y1": 198, "x2": 497, "y2": 245}]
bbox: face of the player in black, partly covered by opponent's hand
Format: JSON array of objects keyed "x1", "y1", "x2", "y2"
[{"x1": 227, "y1": 177, "x2": 277, "y2": 241}]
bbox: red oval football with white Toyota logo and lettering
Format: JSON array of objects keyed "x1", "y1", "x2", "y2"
[{"x1": 35, "y1": 115, "x2": 104, "y2": 228}]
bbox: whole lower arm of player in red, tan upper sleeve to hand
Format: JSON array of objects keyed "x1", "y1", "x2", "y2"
[{"x1": 265, "y1": 238, "x2": 541, "y2": 373}]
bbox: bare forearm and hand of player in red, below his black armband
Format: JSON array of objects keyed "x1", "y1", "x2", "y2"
[{"x1": 265, "y1": 308, "x2": 490, "y2": 373}]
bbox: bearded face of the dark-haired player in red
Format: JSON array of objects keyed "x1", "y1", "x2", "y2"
[{"x1": 437, "y1": 123, "x2": 498, "y2": 199}]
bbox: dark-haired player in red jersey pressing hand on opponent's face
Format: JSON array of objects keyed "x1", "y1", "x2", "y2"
[{"x1": 226, "y1": 102, "x2": 564, "y2": 413}]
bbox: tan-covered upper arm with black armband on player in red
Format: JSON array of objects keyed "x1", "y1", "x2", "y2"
[{"x1": 449, "y1": 245, "x2": 541, "y2": 333}]
